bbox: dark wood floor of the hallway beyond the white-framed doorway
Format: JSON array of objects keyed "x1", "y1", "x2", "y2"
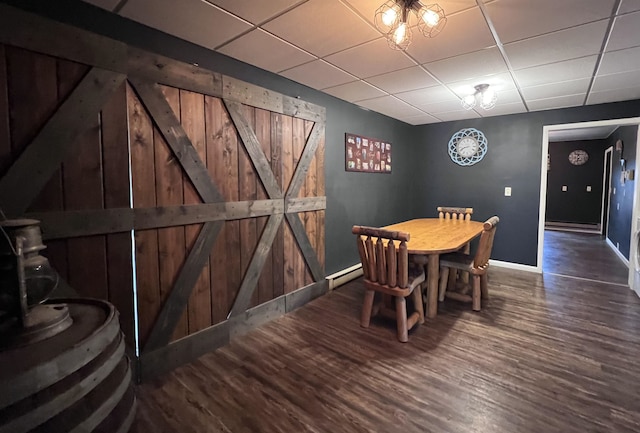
[{"x1": 542, "y1": 230, "x2": 629, "y2": 285}]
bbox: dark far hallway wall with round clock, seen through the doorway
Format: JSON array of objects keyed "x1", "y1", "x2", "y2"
[{"x1": 545, "y1": 139, "x2": 609, "y2": 224}]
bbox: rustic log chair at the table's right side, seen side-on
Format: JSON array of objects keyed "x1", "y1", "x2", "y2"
[{"x1": 439, "y1": 216, "x2": 500, "y2": 311}]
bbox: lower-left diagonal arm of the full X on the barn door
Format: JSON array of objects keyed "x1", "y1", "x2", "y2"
[{"x1": 229, "y1": 214, "x2": 282, "y2": 318}]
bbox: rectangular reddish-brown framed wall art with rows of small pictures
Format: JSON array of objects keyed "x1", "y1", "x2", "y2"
[{"x1": 344, "y1": 132, "x2": 391, "y2": 173}]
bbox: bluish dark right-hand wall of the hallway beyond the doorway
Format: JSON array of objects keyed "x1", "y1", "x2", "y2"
[{"x1": 607, "y1": 126, "x2": 638, "y2": 259}]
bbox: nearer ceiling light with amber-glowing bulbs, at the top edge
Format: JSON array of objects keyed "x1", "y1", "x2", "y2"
[{"x1": 374, "y1": 0, "x2": 447, "y2": 50}]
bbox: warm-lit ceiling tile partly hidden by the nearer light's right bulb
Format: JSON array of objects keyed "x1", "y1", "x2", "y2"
[{"x1": 407, "y1": 5, "x2": 496, "y2": 63}]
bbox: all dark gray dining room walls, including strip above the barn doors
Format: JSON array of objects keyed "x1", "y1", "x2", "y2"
[{"x1": 5, "y1": 0, "x2": 640, "y2": 273}]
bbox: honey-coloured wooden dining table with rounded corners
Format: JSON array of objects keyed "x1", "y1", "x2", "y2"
[{"x1": 384, "y1": 218, "x2": 483, "y2": 318}]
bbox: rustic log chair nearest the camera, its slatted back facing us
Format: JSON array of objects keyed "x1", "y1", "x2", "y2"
[{"x1": 352, "y1": 226, "x2": 425, "y2": 343}]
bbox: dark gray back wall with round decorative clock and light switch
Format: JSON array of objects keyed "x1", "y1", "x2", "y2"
[{"x1": 413, "y1": 106, "x2": 640, "y2": 266}]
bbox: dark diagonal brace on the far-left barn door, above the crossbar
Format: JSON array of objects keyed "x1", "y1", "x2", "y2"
[{"x1": 0, "y1": 68, "x2": 124, "y2": 216}]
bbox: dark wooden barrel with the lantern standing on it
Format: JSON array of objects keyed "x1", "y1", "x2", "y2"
[{"x1": 0, "y1": 299, "x2": 135, "y2": 433}]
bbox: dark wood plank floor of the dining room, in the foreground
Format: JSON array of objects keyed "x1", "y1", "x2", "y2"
[{"x1": 132, "y1": 267, "x2": 640, "y2": 433}]
